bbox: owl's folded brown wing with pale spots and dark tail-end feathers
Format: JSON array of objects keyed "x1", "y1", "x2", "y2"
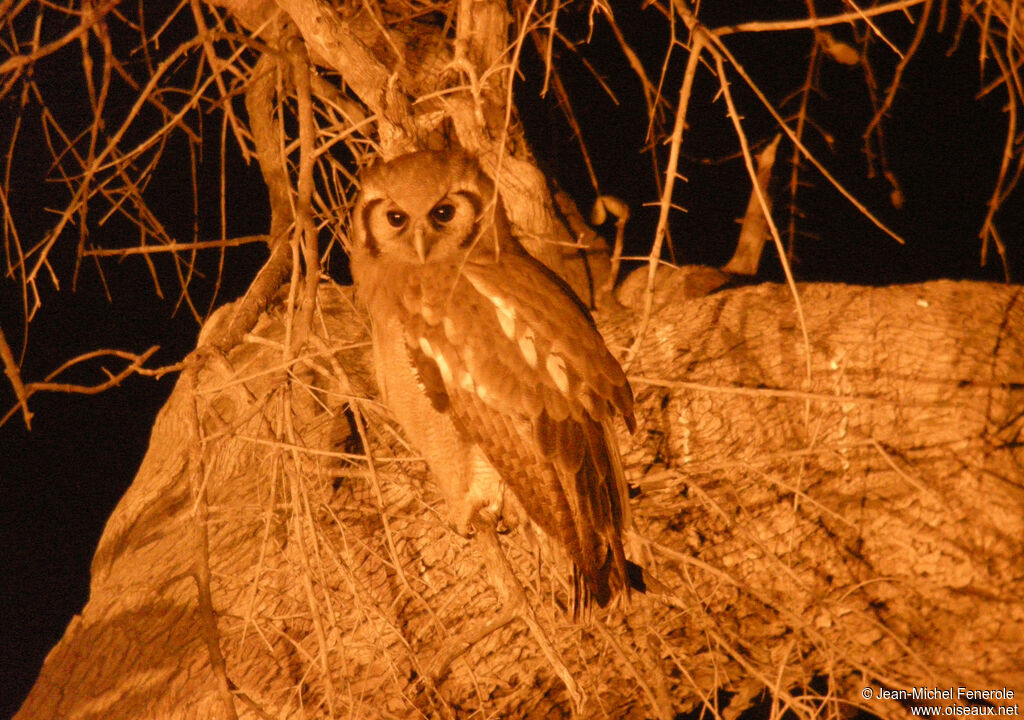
[{"x1": 402, "y1": 254, "x2": 635, "y2": 605}]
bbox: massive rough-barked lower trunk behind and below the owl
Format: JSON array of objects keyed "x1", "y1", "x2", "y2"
[{"x1": 16, "y1": 279, "x2": 1024, "y2": 720}]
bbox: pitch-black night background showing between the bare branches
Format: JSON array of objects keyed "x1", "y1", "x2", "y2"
[{"x1": 0, "y1": 2, "x2": 1024, "y2": 717}]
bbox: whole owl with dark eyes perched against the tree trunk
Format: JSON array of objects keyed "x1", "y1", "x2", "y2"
[{"x1": 350, "y1": 151, "x2": 640, "y2": 608}]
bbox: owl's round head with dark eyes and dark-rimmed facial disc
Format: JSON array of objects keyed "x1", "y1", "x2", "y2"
[{"x1": 354, "y1": 151, "x2": 510, "y2": 264}]
